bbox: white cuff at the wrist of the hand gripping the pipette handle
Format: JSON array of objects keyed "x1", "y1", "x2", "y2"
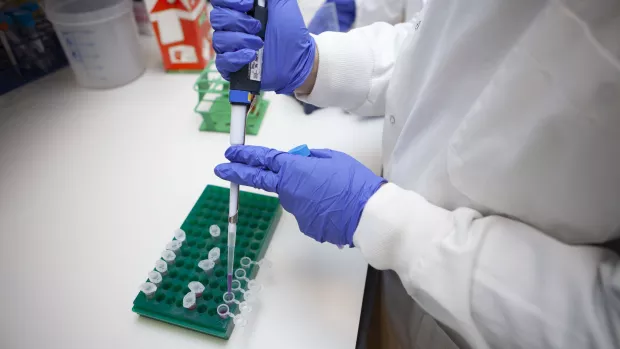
[{"x1": 296, "y1": 32, "x2": 373, "y2": 110}]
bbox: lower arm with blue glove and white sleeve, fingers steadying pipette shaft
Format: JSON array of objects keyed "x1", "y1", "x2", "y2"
[{"x1": 215, "y1": 146, "x2": 620, "y2": 349}]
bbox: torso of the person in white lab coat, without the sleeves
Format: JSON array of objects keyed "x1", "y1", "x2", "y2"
[{"x1": 383, "y1": 0, "x2": 620, "y2": 243}]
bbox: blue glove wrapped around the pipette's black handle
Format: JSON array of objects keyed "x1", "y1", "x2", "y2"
[{"x1": 211, "y1": 0, "x2": 315, "y2": 94}]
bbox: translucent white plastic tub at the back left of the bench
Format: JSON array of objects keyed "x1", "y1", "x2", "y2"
[{"x1": 46, "y1": 0, "x2": 145, "y2": 88}]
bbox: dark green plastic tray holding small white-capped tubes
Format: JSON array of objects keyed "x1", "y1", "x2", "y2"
[{"x1": 132, "y1": 185, "x2": 282, "y2": 339}]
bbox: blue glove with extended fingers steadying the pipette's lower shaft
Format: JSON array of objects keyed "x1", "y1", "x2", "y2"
[{"x1": 215, "y1": 145, "x2": 386, "y2": 246}]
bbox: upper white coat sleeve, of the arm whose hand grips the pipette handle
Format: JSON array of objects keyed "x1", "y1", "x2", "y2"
[{"x1": 297, "y1": 23, "x2": 414, "y2": 116}]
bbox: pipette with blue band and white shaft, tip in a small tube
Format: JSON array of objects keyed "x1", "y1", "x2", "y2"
[{"x1": 227, "y1": 0, "x2": 267, "y2": 292}]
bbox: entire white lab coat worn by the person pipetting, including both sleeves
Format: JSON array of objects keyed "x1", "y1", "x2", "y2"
[{"x1": 299, "y1": 0, "x2": 620, "y2": 349}]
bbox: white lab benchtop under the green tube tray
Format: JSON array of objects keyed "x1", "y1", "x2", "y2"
[{"x1": 0, "y1": 39, "x2": 382, "y2": 349}]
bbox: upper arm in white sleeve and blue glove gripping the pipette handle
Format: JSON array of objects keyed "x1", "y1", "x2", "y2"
[{"x1": 211, "y1": 0, "x2": 414, "y2": 115}]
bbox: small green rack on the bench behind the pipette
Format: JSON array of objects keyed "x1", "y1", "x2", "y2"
[{"x1": 194, "y1": 62, "x2": 269, "y2": 135}]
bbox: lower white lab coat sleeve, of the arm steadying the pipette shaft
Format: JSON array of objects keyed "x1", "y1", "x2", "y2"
[{"x1": 353, "y1": 184, "x2": 620, "y2": 348}]
